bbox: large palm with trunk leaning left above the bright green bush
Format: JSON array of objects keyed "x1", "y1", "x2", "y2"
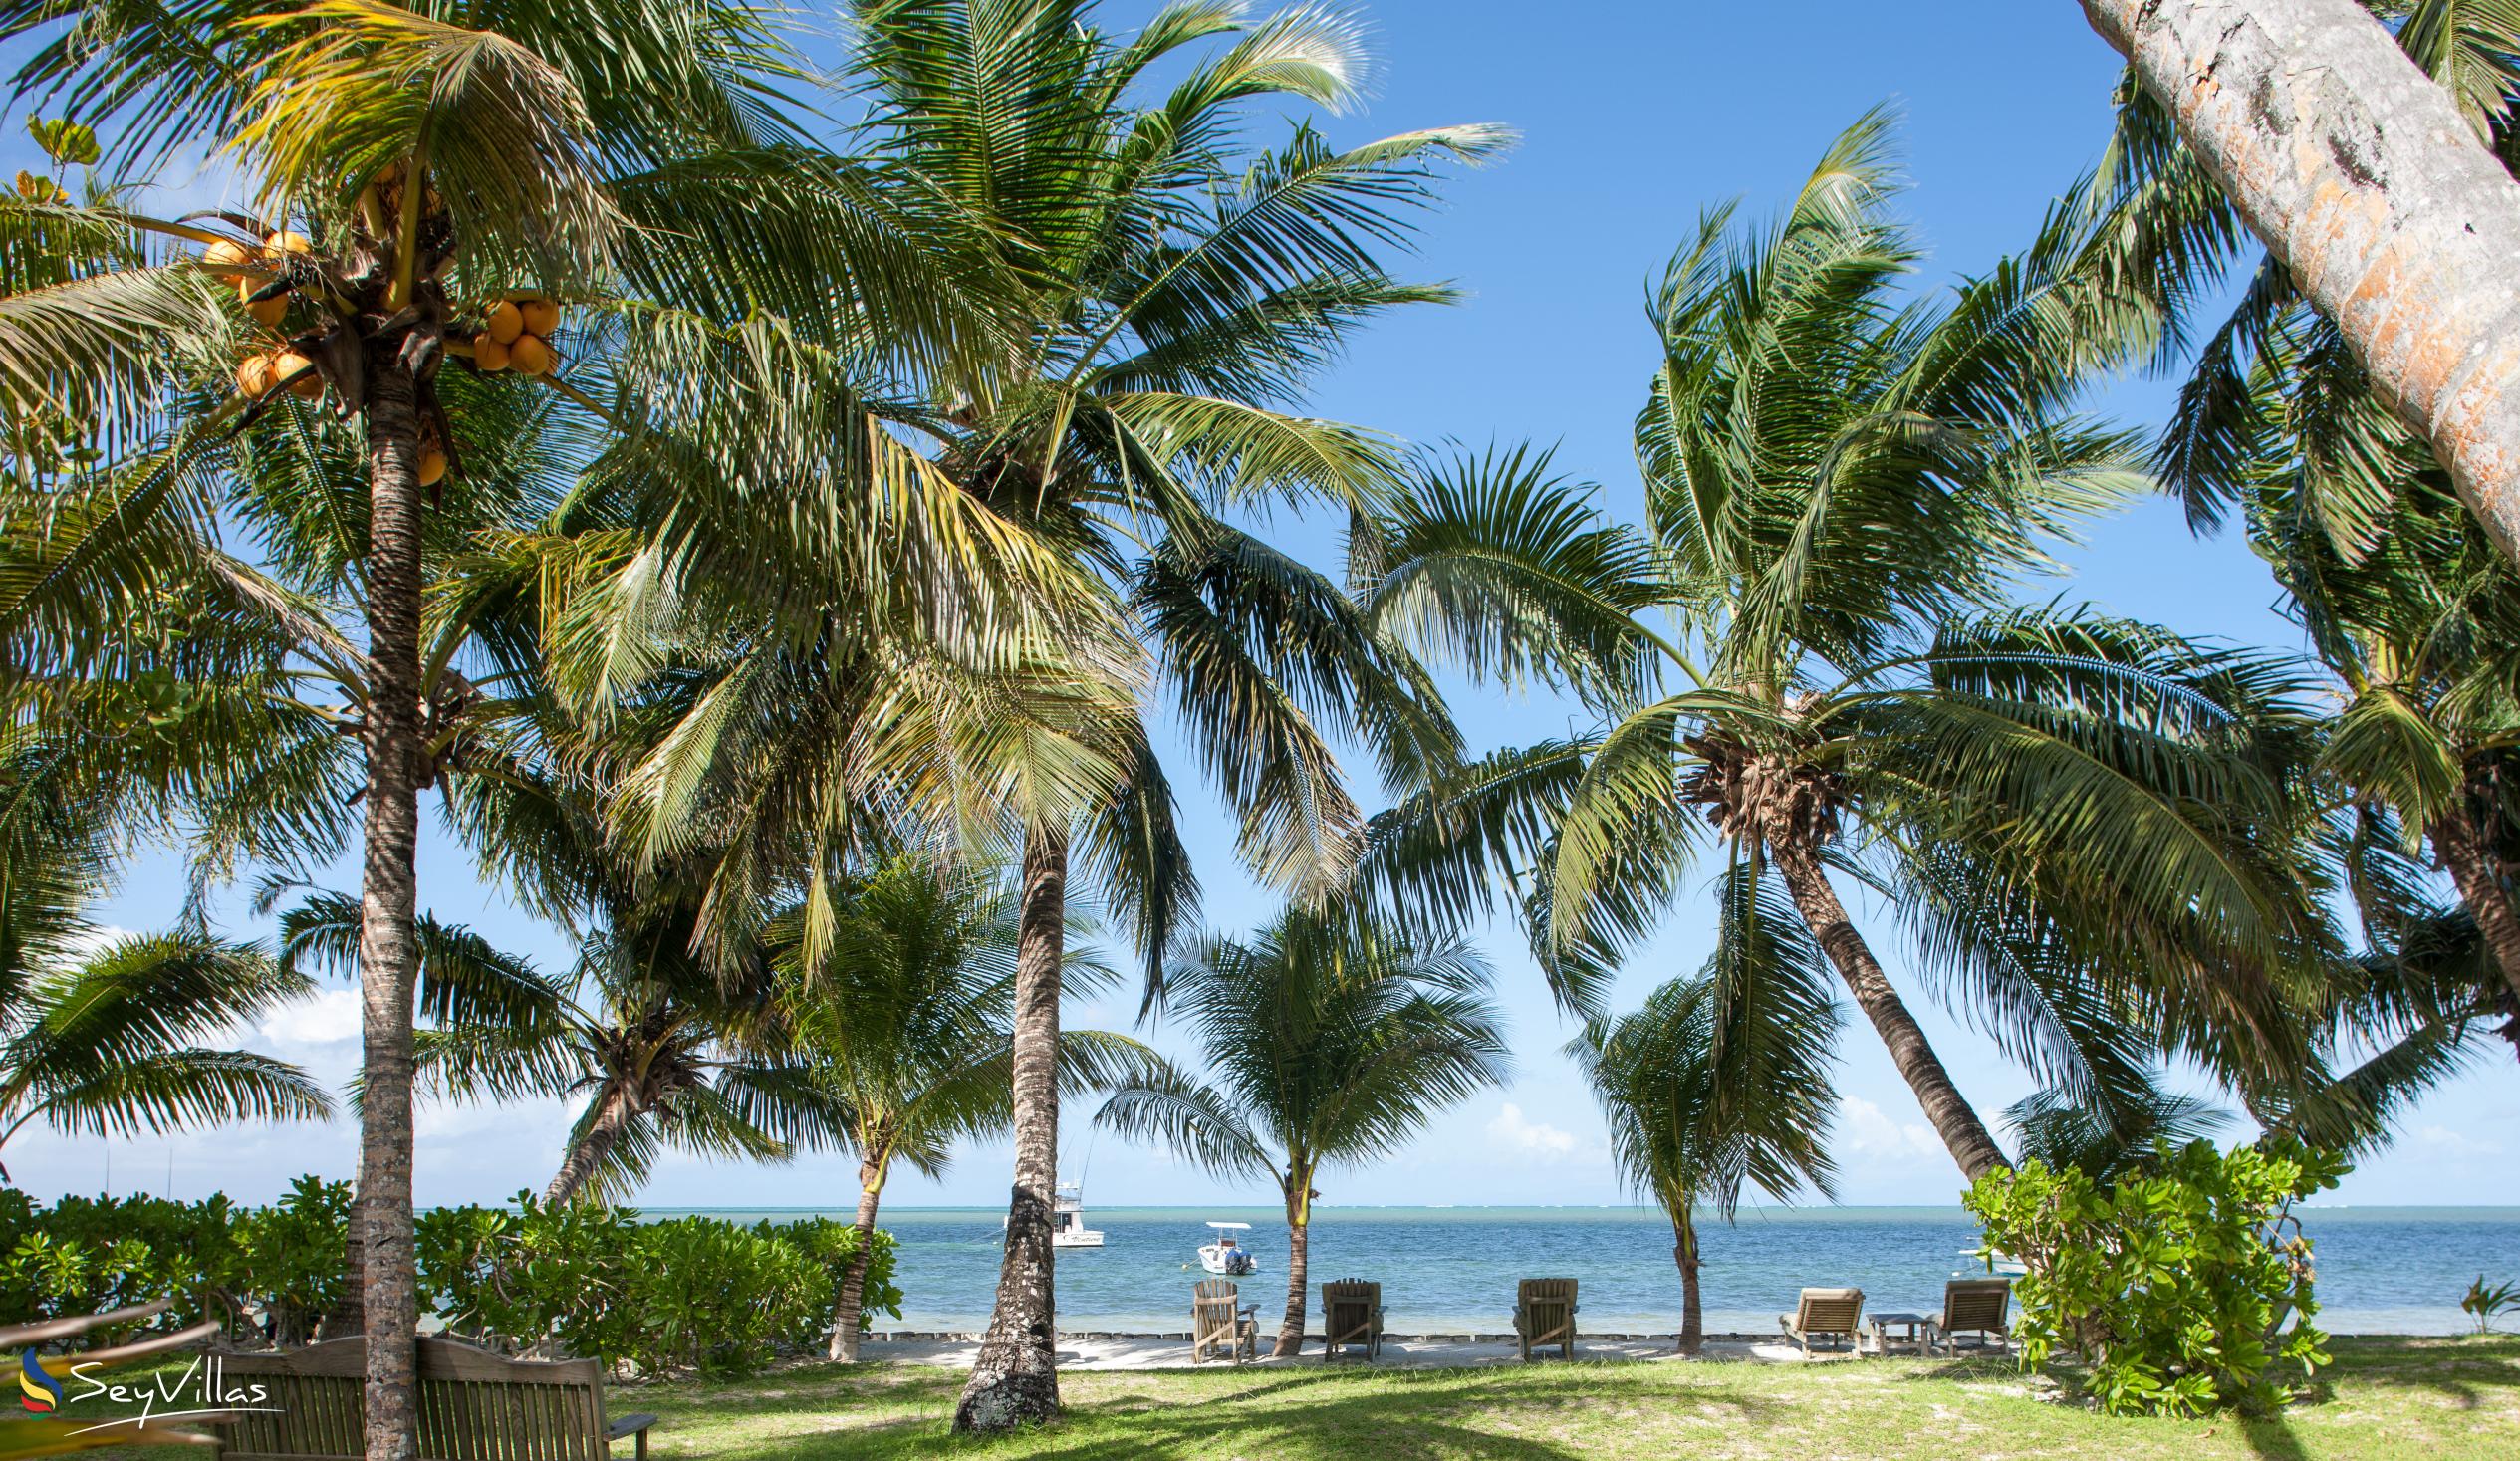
[{"x1": 1356, "y1": 114, "x2": 2324, "y2": 1179}]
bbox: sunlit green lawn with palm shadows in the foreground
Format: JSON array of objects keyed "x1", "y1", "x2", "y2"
[{"x1": 610, "y1": 1336, "x2": 2520, "y2": 1461}]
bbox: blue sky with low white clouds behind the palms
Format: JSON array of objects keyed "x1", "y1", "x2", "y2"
[{"x1": 0, "y1": 0, "x2": 2520, "y2": 1207}]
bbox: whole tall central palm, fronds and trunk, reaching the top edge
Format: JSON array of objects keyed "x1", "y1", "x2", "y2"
[{"x1": 544, "y1": 0, "x2": 1502, "y2": 1431}]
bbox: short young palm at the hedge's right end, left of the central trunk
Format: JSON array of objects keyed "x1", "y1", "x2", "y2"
[{"x1": 769, "y1": 858, "x2": 1156, "y2": 1362}]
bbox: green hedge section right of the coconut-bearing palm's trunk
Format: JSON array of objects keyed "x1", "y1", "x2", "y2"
[{"x1": 418, "y1": 1191, "x2": 902, "y2": 1372}]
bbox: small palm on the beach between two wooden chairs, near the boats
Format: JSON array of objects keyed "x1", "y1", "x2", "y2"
[{"x1": 1094, "y1": 909, "x2": 1507, "y2": 1355}]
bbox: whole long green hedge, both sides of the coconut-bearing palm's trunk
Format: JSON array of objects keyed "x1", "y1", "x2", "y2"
[{"x1": 0, "y1": 1176, "x2": 902, "y2": 1372}]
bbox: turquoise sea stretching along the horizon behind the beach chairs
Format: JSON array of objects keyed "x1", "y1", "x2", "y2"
[{"x1": 660, "y1": 1207, "x2": 2520, "y2": 1336}]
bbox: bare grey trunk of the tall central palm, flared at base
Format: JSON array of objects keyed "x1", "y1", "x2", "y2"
[{"x1": 952, "y1": 827, "x2": 1069, "y2": 1433}]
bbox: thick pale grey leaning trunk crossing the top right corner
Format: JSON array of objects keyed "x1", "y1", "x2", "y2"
[{"x1": 2082, "y1": 0, "x2": 2520, "y2": 560}]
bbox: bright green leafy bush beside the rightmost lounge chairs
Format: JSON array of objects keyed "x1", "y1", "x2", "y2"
[{"x1": 1965, "y1": 1141, "x2": 2344, "y2": 1415}]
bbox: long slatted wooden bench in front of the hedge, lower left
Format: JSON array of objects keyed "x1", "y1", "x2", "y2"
[{"x1": 219, "y1": 1336, "x2": 655, "y2": 1461}]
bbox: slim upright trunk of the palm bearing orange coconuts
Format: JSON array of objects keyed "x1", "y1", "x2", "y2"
[{"x1": 356, "y1": 351, "x2": 421, "y2": 1461}]
